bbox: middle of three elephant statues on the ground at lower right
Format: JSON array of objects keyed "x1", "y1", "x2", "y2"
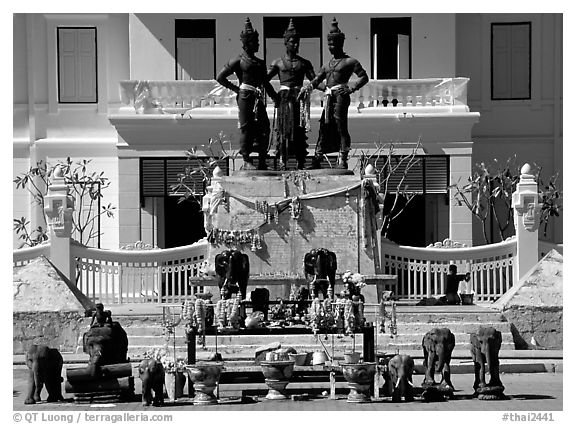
[{"x1": 422, "y1": 328, "x2": 456, "y2": 391}]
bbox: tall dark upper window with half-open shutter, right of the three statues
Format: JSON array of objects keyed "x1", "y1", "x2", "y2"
[{"x1": 370, "y1": 18, "x2": 412, "y2": 79}]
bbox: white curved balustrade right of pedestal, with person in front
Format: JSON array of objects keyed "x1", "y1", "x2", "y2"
[{"x1": 382, "y1": 238, "x2": 517, "y2": 301}]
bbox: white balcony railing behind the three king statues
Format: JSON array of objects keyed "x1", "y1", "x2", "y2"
[{"x1": 120, "y1": 78, "x2": 469, "y2": 113}]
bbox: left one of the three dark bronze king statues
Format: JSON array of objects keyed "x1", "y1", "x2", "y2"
[{"x1": 216, "y1": 18, "x2": 276, "y2": 170}]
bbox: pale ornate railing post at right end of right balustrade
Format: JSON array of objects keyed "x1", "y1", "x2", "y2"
[{"x1": 512, "y1": 164, "x2": 542, "y2": 283}]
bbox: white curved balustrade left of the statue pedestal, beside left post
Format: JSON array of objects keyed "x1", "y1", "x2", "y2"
[{"x1": 71, "y1": 240, "x2": 208, "y2": 304}]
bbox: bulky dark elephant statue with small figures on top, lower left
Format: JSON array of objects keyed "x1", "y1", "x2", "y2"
[{"x1": 83, "y1": 321, "x2": 128, "y2": 378}]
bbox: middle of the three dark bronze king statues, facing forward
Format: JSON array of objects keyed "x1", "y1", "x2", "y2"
[{"x1": 268, "y1": 19, "x2": 316, "y2": 171}]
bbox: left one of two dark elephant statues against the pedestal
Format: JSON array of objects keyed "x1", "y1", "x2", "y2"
[{"x1": 214, "y1": 249, "x2": 250, "y2": 300}]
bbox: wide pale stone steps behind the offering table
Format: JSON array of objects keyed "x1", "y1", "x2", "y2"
[{"x1": 97, "y1": 304, "x2": 514, "y2": 361}]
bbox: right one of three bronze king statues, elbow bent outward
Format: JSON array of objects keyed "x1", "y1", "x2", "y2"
[{"x1": 306, "y1": 18, "x2": 368, "y2": 169}]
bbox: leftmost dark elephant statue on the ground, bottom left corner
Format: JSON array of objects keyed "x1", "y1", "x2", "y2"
[{"x1": 24, "y1": 345, "x2": 64, "y2": 405}]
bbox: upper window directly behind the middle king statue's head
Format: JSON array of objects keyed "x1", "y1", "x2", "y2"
[{"x1": 264, "y1": 16, "x2": 322, "y2": 71}]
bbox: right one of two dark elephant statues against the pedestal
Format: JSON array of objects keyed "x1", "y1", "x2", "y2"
[{"x1": 304, "y1": 248, "x2": 338, "y2": 299}]
